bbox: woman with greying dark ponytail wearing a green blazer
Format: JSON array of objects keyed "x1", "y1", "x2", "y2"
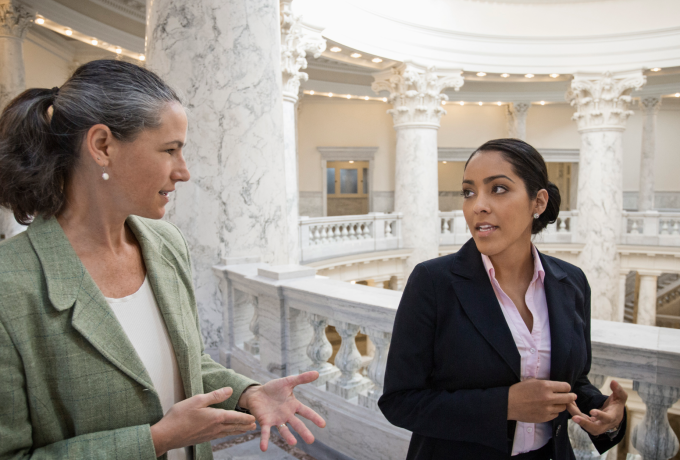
[{"x1": 0, "y1": 60, "x2": 325, "y2": 460}]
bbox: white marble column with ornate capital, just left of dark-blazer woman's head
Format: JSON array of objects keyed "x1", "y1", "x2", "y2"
[{"x1": 372, "y1": 64, "x2": 463, "y2": 277}]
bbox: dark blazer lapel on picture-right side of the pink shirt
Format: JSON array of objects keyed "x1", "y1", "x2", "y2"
[{"x1": 539, "y1": 253, "x2": 576, "y2": 382}]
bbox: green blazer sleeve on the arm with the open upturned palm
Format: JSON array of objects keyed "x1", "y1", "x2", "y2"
[{"x1": 173, "y1": 224, "x2": 258, "y2": 410}]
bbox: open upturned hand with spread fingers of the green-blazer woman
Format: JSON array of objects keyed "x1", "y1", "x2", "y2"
[{"x1": 238, "y1": 371, "x2": 326, "y2": 452}]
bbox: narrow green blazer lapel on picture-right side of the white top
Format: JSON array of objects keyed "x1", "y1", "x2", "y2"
[{"x1": 127, "y1": 216, "x2": 196, "y2": 398}]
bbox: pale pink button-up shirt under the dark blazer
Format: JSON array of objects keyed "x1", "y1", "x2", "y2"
[{"x1": 482, "y1": 245, "x2": 552, "y2": 455}]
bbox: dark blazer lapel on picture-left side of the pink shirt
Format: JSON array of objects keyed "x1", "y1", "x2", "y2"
[{"x1": 452, "y1": 238, "x2": 521, "y2": 381}]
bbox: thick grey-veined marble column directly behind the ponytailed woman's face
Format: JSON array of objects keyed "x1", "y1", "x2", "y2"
[{"x1": 146, "y1": 0, "x2": 297, "y2": 349}]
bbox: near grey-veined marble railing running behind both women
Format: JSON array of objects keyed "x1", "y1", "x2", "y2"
[{"x1": 214, "y1": 262, "x2": 680, "y2": 460}]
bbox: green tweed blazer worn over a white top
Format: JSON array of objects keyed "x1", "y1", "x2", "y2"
[{"x1": 0, "y1": 216, "x2": 256, "y2": 460}]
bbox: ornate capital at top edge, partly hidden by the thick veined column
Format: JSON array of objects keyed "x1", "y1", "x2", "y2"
[{"x1": 281, "y1": 0, "x2": 326, "y2": 102}]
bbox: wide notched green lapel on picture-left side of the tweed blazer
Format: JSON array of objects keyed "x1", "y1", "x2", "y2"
[{"x1": 27, "y1": 217, "x2": 155, "y2": 392}]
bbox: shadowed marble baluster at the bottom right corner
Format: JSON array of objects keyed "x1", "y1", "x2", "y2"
[{"x1": 632, "y1": 381, "x2": 680, "y2": 460}]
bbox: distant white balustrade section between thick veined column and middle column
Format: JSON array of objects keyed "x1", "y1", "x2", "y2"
[{"x1": 300, "y1": 212, "x2": 401, "y2": 263}]
